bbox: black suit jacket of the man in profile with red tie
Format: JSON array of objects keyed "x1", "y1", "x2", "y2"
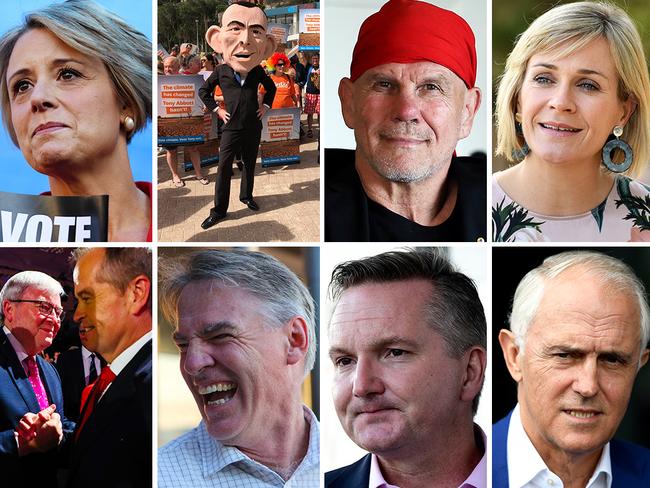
[{"x1": 65, "y1": 341, "x2": 152, "y2": 488}]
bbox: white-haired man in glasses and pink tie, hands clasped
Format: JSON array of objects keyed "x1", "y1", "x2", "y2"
[{"x1": 0, "y1": 271, "x2": 74, "y2": 486}]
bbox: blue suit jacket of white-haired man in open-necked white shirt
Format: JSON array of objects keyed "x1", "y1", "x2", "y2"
[{"x1": 492, "y1": 412, "x2": 650, "y2": 488}]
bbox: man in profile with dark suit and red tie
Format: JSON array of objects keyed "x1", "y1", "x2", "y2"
[{"x1": 65, "y1": 248, "x2": 152, "y2": 488}]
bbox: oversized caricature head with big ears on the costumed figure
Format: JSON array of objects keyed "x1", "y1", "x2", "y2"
[{"x1": 205, "y1": 2, "x2": 276, "y2": 74}]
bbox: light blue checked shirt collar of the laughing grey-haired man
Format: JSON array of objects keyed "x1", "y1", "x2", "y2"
[{"x1": 198, "y1": 405, "x2": 320, "y2": 481}]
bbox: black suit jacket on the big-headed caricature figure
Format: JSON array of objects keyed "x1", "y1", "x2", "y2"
[{"x1": 199, "y1": 64, "x2": 276, "y2": 130}]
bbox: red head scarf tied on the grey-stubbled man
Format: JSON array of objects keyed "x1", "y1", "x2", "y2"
[{"x1": 350, "y1": 0, "x2": 476, "y2": 88}]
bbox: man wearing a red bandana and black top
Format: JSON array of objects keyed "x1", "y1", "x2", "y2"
[{"x1": 325, "y1": 0, "x2": 486, "y2": 242}]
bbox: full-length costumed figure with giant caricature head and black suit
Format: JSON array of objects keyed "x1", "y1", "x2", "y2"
[{"x1": 199, "y1": 2, "x2": 276, "y2": 229}]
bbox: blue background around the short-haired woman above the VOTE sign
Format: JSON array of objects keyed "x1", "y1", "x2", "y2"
[{"x1": 0, "y1": 0, "x2": 151, "y2": 195}]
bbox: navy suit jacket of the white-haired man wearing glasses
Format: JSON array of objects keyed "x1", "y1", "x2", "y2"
[{"x1": 0, "y1": 328, "x2": 74, "y2": 486}]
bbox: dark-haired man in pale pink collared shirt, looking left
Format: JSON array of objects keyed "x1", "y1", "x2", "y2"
[{"x1": 325, "y1": 249, "x2": 487, "y2": 488}]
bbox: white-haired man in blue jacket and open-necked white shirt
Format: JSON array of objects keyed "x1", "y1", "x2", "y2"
[{"x1": 492, "y1": 251, "x2": 650, "y2": 488}]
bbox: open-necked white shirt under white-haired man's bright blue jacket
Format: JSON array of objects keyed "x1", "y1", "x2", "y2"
[{"x1": 507, "y1": 404, "x2": 612, "y2": 488}]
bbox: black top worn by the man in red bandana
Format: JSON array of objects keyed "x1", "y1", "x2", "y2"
[{"x1": 325, "y1": 149, "x2": 486, "y2": 242}]
